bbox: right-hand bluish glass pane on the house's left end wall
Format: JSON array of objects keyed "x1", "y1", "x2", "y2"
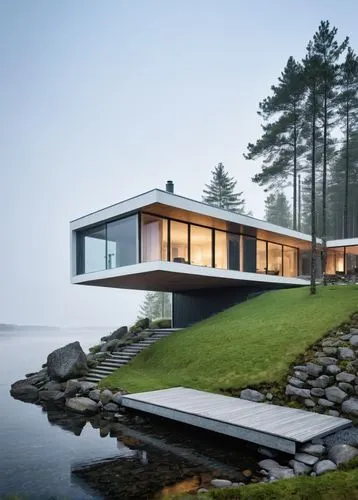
[{"x1": 107, "y1": 215, "x2": 137, "y2": 269}]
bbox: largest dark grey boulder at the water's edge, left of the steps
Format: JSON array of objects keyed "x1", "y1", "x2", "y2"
[{"x1": 47, "y1": 341, "x2": 88, "y2": 382}]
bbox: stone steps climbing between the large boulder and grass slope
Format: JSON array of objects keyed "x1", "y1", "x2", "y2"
[{"x1": 85, "y1": 328, "x2": 180, "y2": 383}]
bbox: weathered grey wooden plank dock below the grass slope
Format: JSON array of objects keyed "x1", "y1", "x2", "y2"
[{"x1": 122, "y1": 387, "x2": 352, "y2": 454}]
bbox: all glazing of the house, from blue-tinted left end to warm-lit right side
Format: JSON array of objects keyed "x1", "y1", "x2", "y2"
[{"x1": 77, "y1": 213, "x2": 302, "y2": 276}]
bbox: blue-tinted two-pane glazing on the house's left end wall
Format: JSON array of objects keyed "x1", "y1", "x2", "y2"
[{"x1": 77, "y1": 215, "x2": 138, "y2": 274}]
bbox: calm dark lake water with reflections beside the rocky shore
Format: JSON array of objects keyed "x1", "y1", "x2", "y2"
[{"x1": 0, "y1": 329, "x2": 257, "y2": 500}]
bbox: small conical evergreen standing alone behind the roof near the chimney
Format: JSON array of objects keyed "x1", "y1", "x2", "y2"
[{"x1": 203, "y1": 163, "x2": 245, "y2": 213}]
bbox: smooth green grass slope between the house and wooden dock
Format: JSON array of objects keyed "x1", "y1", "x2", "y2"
[{"x1": 100, "y1": 285, "x2": 358, "y2": 392}]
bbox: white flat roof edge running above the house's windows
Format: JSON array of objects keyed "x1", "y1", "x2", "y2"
[{"x1": 71, "y1": 189, "x2": 321, "y2": 243}]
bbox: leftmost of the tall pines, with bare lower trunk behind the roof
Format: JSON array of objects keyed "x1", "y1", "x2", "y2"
[{"x1": 244, "y1": 57, "x2": 305, "y2": 229}]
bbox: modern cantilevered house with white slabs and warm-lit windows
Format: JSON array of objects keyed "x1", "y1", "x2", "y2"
[{"x1": 70, "y1": 181, "x2": 358, "y2": 327}]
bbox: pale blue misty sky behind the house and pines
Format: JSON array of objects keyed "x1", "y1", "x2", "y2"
[{"x1": 0, "y1": 0, "x2": 358, "y2": 326}]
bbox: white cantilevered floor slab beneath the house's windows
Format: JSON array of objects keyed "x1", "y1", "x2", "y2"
[{"x1": 72, "y1": 261, "x2": 309, "y2": 292}]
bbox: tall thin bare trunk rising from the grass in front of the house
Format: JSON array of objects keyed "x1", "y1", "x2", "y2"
[{"x1": 311, "y1": 83, "x2": 317, "y2": 295}]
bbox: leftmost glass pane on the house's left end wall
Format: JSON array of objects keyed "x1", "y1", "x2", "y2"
[{"x1": 77, "y1": 224, "x2": 106, "y2": 274}]
